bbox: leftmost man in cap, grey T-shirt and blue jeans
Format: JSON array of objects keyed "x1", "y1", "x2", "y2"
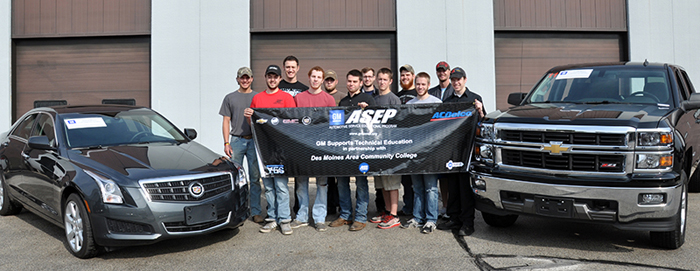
[{"x1": 219, "y1": 67, "x2": 265, "y2": 223}]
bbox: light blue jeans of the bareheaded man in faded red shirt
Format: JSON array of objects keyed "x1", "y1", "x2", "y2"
[{"x1": 296, "y1": 177, "x2": 328, "y2": 223}]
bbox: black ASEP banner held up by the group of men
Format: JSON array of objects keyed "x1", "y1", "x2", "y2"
[{"x1": 251, "y1": 103, "x2": 478, "y2": 177}]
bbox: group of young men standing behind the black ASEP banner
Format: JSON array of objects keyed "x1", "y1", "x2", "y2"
[{"x1": 219, "y1": 56, "x2": 485, "y2": 236}]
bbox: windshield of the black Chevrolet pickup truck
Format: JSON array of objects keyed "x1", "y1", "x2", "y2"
[{"x1": 526, "y1": 67, "x2": 672, "y2": 105}]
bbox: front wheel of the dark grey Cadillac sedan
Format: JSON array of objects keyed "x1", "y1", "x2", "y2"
[{"x1": 63, "y1": 194, "x2": 99, "y2": 259}]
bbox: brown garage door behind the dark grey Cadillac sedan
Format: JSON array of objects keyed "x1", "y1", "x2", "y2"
[{"x1": 13, "y1": 37, "x2": 151, "y2": 119}]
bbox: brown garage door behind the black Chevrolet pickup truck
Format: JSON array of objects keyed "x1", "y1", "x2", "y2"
[{"x1": 495, "y1": 33, "x2": 625, "y2": 109}]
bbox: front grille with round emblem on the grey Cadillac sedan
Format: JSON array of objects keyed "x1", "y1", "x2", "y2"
[{"x1": 141, "y1": 173, "x2": 232, "y2": 201}]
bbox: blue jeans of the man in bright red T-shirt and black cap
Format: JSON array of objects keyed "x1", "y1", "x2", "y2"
[{"x1": 263, "y1": 177, "x2": 292, "y2": 223}]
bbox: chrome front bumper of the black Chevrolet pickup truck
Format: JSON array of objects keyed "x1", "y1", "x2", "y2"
[{"x1": 471, "y1": 172, "x2": 682, "y2": 231}]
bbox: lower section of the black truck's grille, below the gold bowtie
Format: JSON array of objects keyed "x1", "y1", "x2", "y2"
[{"x1": 502, "y1": 150, "x2": 625, "y2": 172}]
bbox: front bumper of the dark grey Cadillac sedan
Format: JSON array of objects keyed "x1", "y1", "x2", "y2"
[{"x1": 90, "y1": 186, "x2": 250, "y2": 247}]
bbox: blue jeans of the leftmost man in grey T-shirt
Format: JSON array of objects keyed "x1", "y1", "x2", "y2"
[{"x1": 230, "y1": 136, "x2": 262, "y2": 218}]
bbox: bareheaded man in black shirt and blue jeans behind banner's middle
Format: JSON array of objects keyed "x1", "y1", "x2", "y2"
[{"x1": 329, "y1": 70, "x2": 376, "y2": 231}]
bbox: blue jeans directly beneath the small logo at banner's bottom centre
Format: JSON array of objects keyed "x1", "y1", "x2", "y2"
[{"x1": 338, "y1": 176, "x2": 369, "y2": 223}]
